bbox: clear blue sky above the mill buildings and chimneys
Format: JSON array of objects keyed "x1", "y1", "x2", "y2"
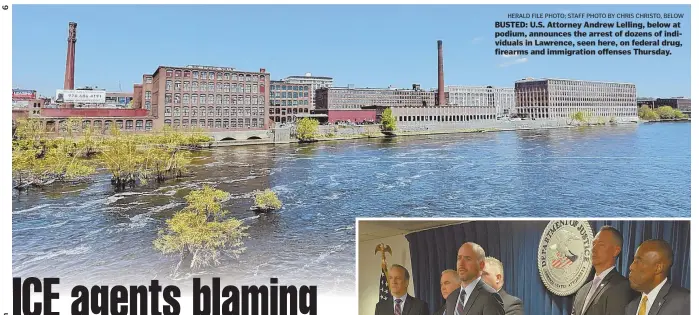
[{"x1": 12, "y1": 5, "x2": 691, "y2": 97}]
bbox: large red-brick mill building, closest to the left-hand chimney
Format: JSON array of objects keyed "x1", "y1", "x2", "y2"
[{"x1": 134, "y1": 66, "x2": 270, "y2": 131}]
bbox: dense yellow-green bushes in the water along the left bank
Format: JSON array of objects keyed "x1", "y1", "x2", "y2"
[{"x1": 12, "y1": 118, "x2": 213, "y2": 190}]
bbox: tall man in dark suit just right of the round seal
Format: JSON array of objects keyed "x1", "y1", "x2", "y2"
[{"x1": 571, "y1": 226, "x2": 638, "y2": 315}]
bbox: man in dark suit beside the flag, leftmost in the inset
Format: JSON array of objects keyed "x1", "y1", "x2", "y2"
[{"x1": 374, "y1": 265, "x2": 430, "y2": 315}]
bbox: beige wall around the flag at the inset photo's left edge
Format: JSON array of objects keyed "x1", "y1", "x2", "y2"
[{"x1": 357, "y1": 235, "x2": 415, "y2": 315}]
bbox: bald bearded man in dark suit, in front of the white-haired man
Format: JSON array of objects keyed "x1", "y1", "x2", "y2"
[{"x1": 446, "y1": 243, "x2": 505, "y2": 315}]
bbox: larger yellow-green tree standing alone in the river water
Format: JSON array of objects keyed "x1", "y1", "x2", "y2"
[{"x1": 153, "y1": 186, "x2": 248, "y2": 269}]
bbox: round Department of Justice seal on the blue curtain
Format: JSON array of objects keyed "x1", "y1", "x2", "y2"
[{"x1": 537, "y1": 220, "x2": 595, "y2": 296}]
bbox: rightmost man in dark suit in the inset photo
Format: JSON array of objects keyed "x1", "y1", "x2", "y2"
[{"x1": 625, "y1": 240, "x2": 690, "y2": 315}]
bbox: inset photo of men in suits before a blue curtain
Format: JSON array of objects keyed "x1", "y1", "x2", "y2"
[{"x1": 356, "y1": 218, "x2": 691, "y2": 315}]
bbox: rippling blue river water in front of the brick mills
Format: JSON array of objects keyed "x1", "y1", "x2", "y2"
[{"x1": 12, "y1": 123, "x2": 690, "y2": 293}]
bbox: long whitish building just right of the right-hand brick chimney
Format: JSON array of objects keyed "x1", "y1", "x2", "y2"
[{"x1": 444, "y1": 85, "x2": 515, "y2": 116}]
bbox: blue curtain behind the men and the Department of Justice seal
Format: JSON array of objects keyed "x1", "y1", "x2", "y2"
[{"x1": 405, "y1": 221, "x2": 690, "y2": 315}]
